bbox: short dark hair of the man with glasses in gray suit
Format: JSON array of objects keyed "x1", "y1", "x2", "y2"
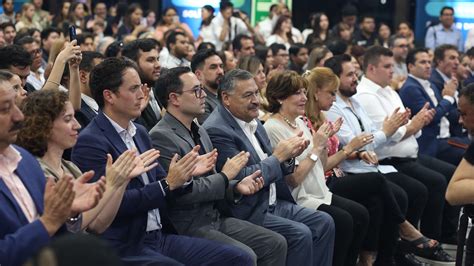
[{"x1": 155, "y1": 67, "x2": 191, "y2": 108}]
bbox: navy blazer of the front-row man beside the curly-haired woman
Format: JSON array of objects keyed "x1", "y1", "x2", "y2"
[{"x1": 71, "y1": 112, "x2": 173, "y2": 256}]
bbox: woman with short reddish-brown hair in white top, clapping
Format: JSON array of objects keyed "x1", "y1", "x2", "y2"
[{"x1": 264, "y1": 69, "x2": 369, "y2": 266}]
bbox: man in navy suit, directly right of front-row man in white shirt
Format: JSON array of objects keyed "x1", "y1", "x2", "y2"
[{"x1": 400, "y1": 46, "x2": 469, "y2": 165}]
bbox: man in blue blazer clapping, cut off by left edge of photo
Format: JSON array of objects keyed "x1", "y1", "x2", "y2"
[{"x1": 0, "y1": 75, "x2": 90, "y2": 265}]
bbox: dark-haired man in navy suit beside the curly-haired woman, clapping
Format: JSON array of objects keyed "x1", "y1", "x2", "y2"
[{"x1": 72, "y1": 58, "x2": 251, "y2": 265}]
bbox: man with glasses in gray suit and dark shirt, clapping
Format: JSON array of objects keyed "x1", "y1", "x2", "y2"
[{"x1": 150, "y1": 67, "x2": 287, "y2": 265}]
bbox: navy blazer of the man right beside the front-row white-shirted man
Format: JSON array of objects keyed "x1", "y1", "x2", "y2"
[{"x1": 400, "y1": 74, "x2": 458, "y2": 156}]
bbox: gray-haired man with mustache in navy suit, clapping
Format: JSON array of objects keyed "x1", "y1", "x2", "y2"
[{"x1": 203, "y1": 69, "x2": 334, "y2": 265}]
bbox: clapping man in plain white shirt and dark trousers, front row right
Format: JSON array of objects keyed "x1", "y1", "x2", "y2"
[{"x1": 355, "y1": 46, "x2": 459, "y2": 254}]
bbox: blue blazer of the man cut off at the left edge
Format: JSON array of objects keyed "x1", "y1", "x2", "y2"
[{"x1": 0, "y1": 146, "x2": 50, "y2": 265}]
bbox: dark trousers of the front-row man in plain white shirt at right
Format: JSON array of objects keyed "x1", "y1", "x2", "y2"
[{"x1": 382, "y1": 155, "x2": 460, "y2": 241}]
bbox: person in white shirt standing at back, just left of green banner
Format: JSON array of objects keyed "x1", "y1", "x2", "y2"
[{"x1": 211, "y1": 0, "x2": 251, "y2": 51}]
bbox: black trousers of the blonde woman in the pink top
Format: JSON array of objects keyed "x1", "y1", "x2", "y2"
[{"x1": 328, "y1": 170, "x2": 427, "y2": 260}]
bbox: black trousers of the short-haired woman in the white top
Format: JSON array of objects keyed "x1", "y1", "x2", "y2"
[{"x1": 318, "y1": 194, "x2": 369, "y2": 266}]
